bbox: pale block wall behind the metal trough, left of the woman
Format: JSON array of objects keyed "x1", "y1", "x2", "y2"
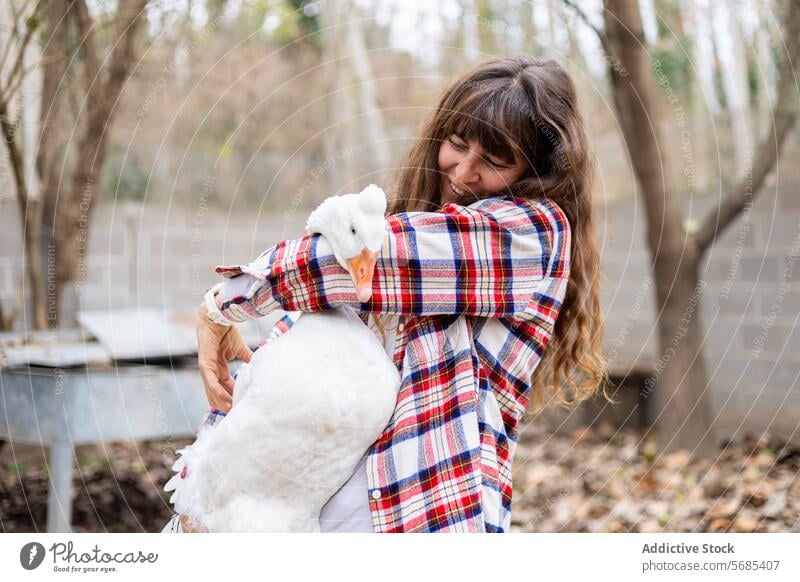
[{"x1": 0, "y1": 201, "x2": 305, "y2": 320}]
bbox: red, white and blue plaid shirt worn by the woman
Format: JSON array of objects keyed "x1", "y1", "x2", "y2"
[{"x1": 216, "y1": 196, "x2": 571, "y2": 532}]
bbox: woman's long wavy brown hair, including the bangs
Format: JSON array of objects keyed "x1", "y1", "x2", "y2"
[{"x1": 389, "y1": 55, "x2": 607, "y2": 410}]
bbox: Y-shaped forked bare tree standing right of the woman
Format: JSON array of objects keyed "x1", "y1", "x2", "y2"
[{"x1": 564, "y1": 0, "x2": 800, "y2": 453}]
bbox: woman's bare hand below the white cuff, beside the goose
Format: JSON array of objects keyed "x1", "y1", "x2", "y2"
[{"x1": 197, "y1": 304, "x2": 253, "y2": 412}]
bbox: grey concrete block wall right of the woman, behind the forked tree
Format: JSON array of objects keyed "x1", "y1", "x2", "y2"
[{"x1": 600, "y1": 184, "x2": 800, "y2": 443}]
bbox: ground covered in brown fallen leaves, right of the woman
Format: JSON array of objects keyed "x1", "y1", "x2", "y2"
[{"x1": 512, "y1": 424, "x2": 800, "y2": 532}]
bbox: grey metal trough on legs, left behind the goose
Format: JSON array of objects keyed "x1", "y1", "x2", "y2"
[{"x1": 0, "y1": 310, "x2": 278, "y2": 532}]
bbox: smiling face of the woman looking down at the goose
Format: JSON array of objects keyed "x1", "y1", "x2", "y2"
[{"x1": 439, "y1": 135, "x2": 525, "y2": 206}]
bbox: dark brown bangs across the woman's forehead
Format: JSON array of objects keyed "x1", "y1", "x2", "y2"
[{"x1": 445, "y1": 87, "x2": 534, "y2": 165}]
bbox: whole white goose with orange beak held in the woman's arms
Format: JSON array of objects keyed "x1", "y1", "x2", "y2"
[{"x1": 165, "y1": 185, "x2": 400, "y2": 532}]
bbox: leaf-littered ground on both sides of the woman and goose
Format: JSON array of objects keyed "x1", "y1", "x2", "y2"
[{"x1": 0, "y1": 424, "x2": 800, "y2": 532}]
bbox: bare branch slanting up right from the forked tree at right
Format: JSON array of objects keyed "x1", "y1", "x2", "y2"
[{"x1": 694, "y1": 0, "x2": 800, "y2": 254}]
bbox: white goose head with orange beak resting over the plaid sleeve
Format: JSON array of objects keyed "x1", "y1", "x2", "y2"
[{"x1": 306, "y1": 184, "x2": 386, "y2": 303}]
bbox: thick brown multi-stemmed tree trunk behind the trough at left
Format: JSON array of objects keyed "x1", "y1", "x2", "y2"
[{"x1": 40, "y1": 0, "x2": 148, "y2": 323}]
